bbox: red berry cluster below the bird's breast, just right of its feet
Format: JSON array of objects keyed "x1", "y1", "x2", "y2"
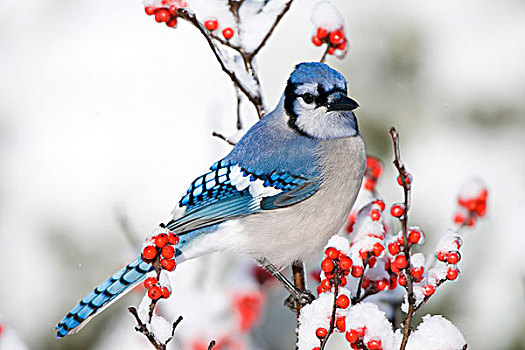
[{"x1": 317, "y1": 247, "x2": 352, "y2": 296}]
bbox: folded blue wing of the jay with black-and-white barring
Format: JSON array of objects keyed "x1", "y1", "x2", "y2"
[{"x1": 168, "y1": 159, "x2": 320, "y2": 234}]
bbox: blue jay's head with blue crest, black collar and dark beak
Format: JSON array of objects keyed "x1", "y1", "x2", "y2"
[{"x1": 284, "y1": 63, "x2": 359, "y2": 140}]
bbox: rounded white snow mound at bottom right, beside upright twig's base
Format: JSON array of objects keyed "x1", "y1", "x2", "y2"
[{"x1": 395, "y1": 315, "x2": 467, "y2": 350}]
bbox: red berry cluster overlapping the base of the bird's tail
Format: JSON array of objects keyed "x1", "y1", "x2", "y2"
[{"x1": 141, "y1": 232, "x2": 179, "y2": 271}]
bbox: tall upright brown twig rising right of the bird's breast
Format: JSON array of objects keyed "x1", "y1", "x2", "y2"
[{"x1": 390, "y1": 127, "x2": 416, "y2": 350}]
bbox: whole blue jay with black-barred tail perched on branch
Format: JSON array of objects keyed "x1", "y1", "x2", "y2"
[{"x1": 56, "y1": 63, "x2": 366, "y2": 338}]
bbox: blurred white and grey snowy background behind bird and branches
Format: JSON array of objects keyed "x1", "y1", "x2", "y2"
[{"x1": 0, "y1": 0, "x2": 525, "y2": 350}]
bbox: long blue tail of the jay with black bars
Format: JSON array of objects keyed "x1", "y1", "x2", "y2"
[{"x1": 55, "y1": 258, "x2": 154, "y2": 338}]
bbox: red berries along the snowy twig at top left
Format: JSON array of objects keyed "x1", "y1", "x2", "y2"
[{"x1": 145, "y1": 0, "x2": 235, "y2": 40}]
